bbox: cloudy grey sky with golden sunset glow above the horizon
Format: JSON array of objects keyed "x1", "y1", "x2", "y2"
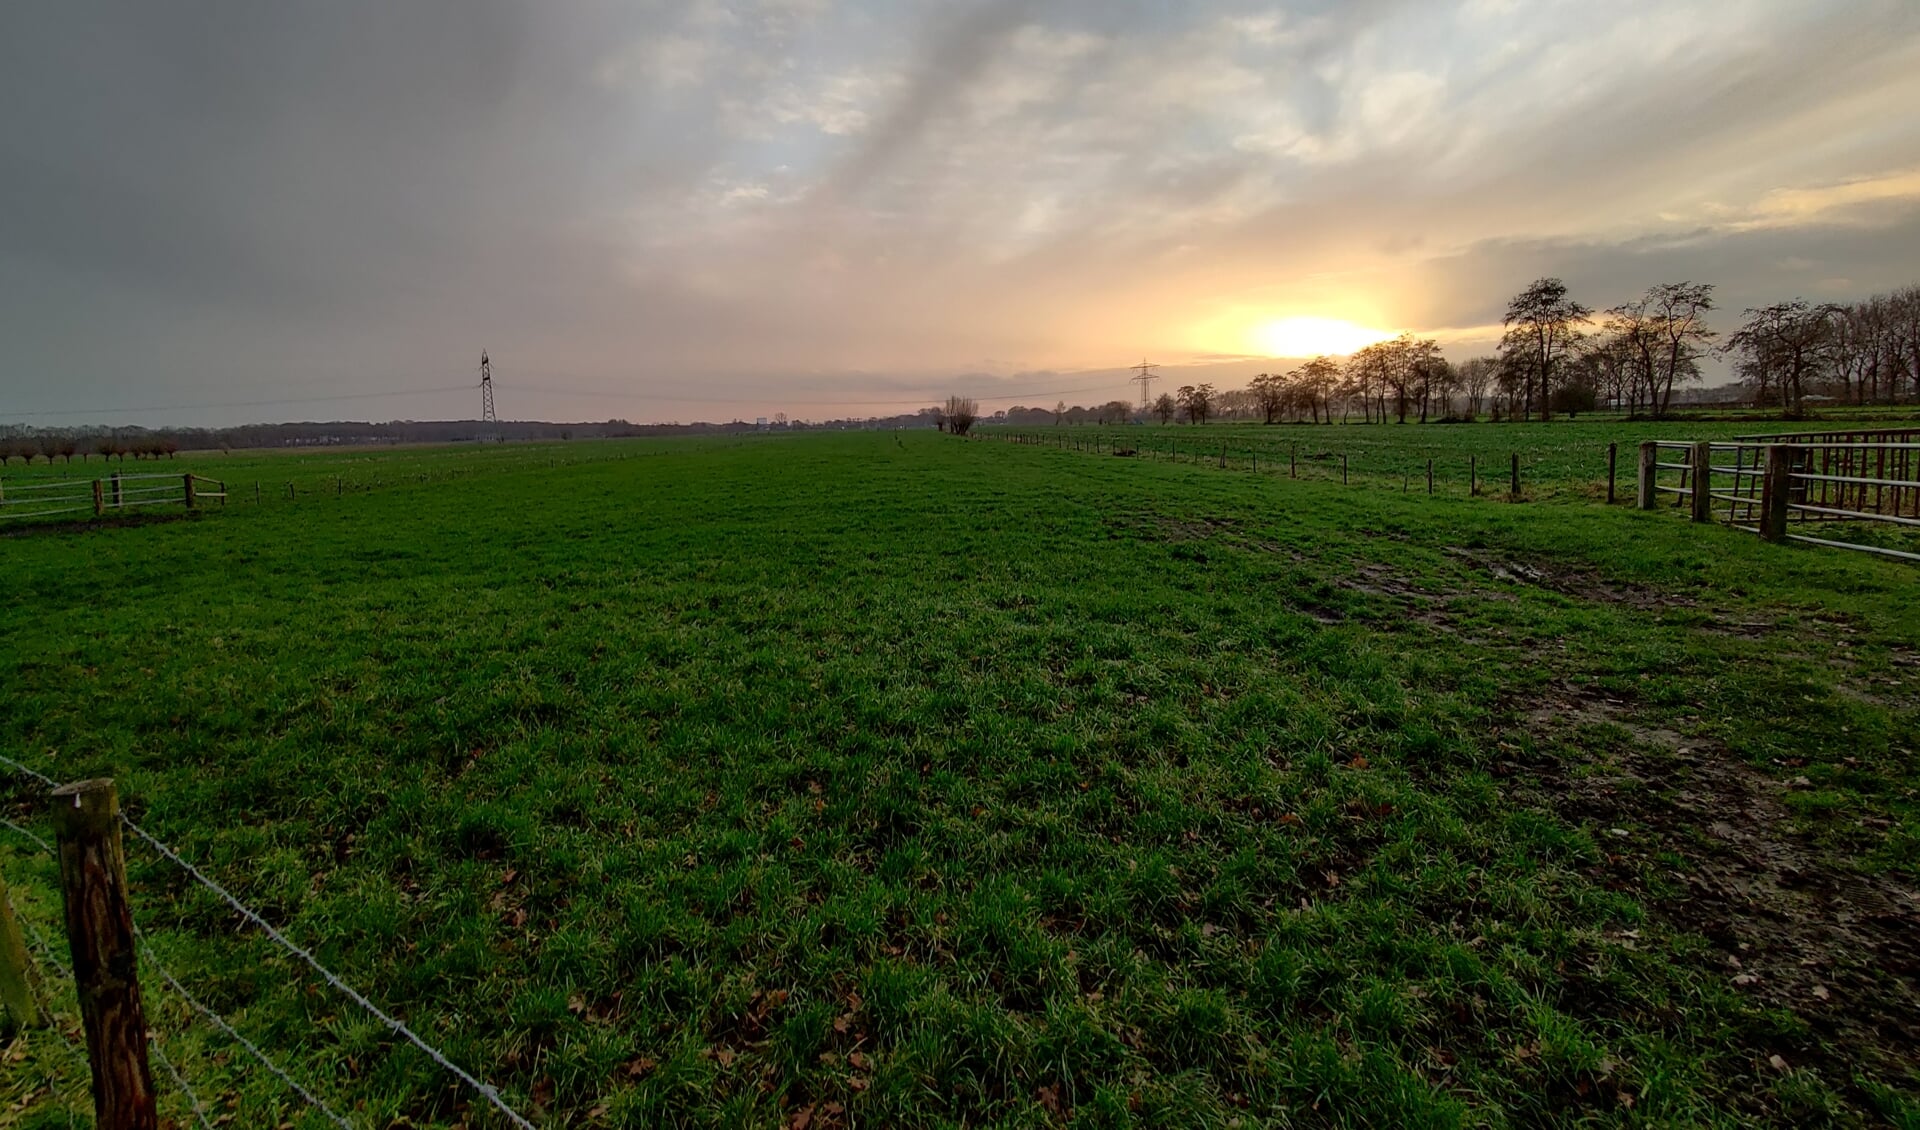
[{"x1": 0, "y1": 0, "x2": 1920, "y2": 426}]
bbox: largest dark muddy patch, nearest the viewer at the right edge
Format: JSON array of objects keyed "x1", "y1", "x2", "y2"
[{"x1": 1526, "y1": 693, "x2": 1920, "y2": 1099}]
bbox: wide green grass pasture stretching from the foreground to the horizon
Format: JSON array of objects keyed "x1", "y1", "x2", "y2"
[{"x1": 0, "y1": 424, "x2": 1920, "y2": 1128}]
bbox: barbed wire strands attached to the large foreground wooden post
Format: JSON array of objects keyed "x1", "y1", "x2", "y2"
[{"x1": 0, "y1": 754, "x2": 534, "y2": 1130}]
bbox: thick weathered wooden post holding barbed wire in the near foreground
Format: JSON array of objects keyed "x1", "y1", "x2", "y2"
[{"x1": 52, "y1": 779, "x2": 159, "y2": 1130}]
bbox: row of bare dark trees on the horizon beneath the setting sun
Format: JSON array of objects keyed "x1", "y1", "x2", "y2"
[{"x1": 975, "y1": 278, "x2": 1920, "y2": 426}]
